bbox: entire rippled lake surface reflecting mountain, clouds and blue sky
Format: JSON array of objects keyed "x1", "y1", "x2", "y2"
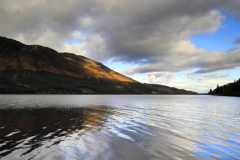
[{"x1": 0, "y1": 95, "x2": 240, "y2": 160}]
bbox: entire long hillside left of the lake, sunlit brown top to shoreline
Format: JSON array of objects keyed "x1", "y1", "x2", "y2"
[{"x1": 0, "y1": 37, "x2": 198, "y2": 94}]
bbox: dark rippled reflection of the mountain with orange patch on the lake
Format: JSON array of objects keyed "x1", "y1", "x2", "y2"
[{"x1": 0, "y1": 106, "x2": 114, "y2": 158}]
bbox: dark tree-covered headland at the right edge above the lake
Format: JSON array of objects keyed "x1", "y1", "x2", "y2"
[{"x1": 208, "y1": 78, "x2": 240, "y2": 97}]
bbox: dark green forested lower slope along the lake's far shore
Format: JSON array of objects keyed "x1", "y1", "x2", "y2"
[{"x1": 0, "y1": 70, "x2": 157, "y2": 94}]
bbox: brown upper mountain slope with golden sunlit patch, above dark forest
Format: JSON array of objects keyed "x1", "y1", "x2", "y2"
[{"x1": 0, "y1": 37, "x2": 138, "y2": 83}]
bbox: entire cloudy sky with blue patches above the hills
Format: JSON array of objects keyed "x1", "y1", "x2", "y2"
[{"x1": 0, "y1": 0, "x2": 240, "y2": 93}]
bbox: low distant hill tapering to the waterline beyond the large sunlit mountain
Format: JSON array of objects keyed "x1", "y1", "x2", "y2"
[{"x1": 145, "y1": 84, "x2": 198, "y2": 94}]
